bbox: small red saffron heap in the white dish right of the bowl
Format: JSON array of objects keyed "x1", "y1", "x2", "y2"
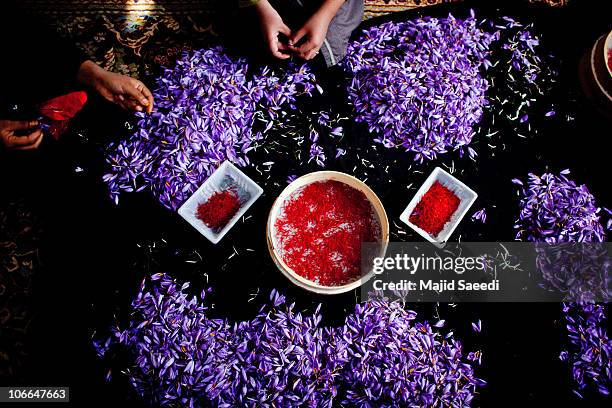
[{"x1": 410, "y1": 181, "x2": 461, "y2": 237}]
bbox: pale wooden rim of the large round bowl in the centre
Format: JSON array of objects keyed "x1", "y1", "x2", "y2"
[{"x1": 266, "y1": 171, "x2": 389, "y2": 295}]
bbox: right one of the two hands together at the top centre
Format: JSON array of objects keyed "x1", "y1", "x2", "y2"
[{"x1": 289, "y1": 0, "x2": 344, "y2": 60}]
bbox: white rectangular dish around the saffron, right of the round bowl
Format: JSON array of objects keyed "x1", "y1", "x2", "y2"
[{"x1": 400, "y1": 167, "x2": 478, "y2": 247}]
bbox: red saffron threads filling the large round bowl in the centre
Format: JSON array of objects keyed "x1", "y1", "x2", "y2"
[{"x1": 275, "y1": 180, "x2": 380, "y2": 286}]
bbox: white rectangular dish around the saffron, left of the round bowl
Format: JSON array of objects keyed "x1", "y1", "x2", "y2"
[{"x1": 178, "y1": 160, "x2": 263, "y2": 244}]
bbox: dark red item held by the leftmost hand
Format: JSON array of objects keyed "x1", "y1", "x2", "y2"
[{"x1": 39, "y1": 91, "x2": 87, "y2": 139}]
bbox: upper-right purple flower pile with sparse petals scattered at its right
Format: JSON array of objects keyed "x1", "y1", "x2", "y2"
[{"x1": 344, "y1": 13, "x2": 556, "y2": 162}]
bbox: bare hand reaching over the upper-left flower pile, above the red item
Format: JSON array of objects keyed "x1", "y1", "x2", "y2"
[{"x1": 77, "y1": 61, "x2": 153, "y2": 112}]
